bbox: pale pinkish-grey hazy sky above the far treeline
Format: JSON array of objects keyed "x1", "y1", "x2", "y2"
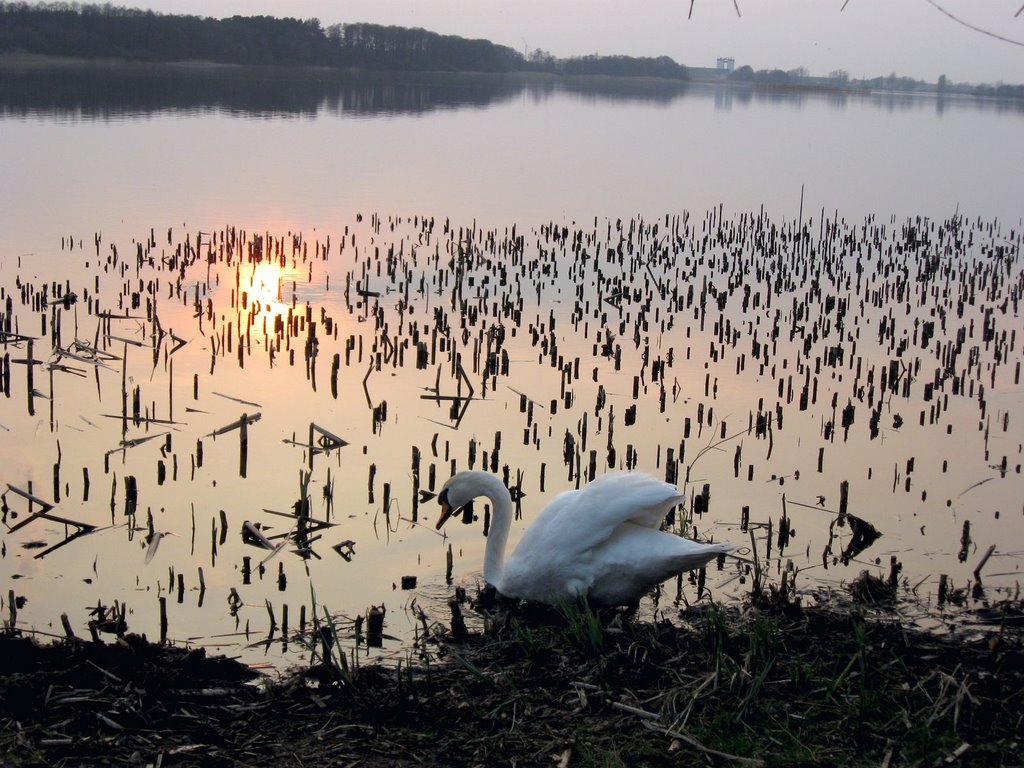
[{"x1": 132, "y1": 0, "x2": 1024, "y2": 83}]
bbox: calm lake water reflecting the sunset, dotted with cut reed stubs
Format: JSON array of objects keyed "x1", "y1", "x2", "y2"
[{"x1": 0, "y1": 64, "x2": 1024, "y2": 664}]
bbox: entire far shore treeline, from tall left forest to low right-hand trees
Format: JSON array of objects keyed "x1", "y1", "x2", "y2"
[{"x1": 0, "y1": 0, "x2": 1024, "y2": 100}]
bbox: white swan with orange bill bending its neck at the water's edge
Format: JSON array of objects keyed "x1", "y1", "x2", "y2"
[{"x1": 436, "y1": 470, "x2": 733, "y2": 605}]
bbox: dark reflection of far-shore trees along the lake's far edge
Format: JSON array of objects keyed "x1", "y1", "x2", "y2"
[{"x1": 0, "y1": 63, "x2": 1024, "y2": 118}]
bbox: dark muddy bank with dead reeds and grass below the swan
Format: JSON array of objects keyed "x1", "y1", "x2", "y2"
[{"x1": 0, "y1": 589, "x2": 1024, "y2": 767}]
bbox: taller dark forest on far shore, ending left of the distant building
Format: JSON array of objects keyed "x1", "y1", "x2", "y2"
[{"x1": 0, "y1": 2, "x2": 687, "y2": 80}]
